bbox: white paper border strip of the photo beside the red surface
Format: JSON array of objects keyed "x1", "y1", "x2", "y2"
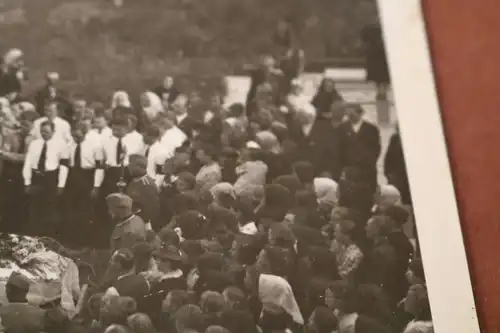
[{"x1": 379, "y1": 0, "x2": 480, "y2": 333}]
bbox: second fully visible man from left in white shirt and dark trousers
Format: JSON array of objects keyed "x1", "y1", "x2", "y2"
[{"x1": 65, "y1": 122, "x2": 104, "y2": 248}]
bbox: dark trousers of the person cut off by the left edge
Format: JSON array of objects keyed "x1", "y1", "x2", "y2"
[{"x1": 0, "y1": 161, "x2": 28, "y2": 234}]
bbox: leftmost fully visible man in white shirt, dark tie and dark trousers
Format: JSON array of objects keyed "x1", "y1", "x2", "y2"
[{"x1": 23, "y1": 120, "x2": 68, "y2": 236}]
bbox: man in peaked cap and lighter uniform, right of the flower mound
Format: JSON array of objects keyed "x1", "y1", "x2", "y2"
[{"x1": 106, "y1": 193, "x2": 146, "y2": 251}]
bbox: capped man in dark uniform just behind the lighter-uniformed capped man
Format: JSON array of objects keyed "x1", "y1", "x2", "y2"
[{"x1": 126, "y1": 155, "x2": 160, "y2": 229}]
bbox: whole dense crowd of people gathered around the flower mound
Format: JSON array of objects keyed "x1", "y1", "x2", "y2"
[{"x1": 0, "y1": 18, "x2": 433, "y2": 333}]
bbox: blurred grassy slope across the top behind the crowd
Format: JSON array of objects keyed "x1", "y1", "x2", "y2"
[{"x1": 0, "y1": 0, "x2": 371, "y2": 101}]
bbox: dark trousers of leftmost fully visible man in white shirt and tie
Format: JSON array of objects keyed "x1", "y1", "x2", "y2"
[{"x1": 29, "y1": 170, "x2": 61, "y2": 240}]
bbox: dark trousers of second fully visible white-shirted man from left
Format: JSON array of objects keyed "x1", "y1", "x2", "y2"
[{"x1": 63, "y1": 168, "x2": 94, "y2": 248}]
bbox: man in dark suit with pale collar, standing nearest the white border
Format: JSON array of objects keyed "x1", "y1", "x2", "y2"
[{"x1": 339, "y1": 105, "x2": 381, "y2": 215}]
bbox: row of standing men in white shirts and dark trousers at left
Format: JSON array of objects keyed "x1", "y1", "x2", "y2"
[{"x1": 0, "y1": 96, "x2": 191, "y2": 246}]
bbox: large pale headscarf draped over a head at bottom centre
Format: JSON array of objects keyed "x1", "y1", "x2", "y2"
[{"x1": 259, "y1": 274, "x2": 304, "y2": 325}]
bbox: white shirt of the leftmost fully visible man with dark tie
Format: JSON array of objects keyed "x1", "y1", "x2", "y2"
[{"x1": 23, "y1": 138, "x2": 69, "y2": 188}]
